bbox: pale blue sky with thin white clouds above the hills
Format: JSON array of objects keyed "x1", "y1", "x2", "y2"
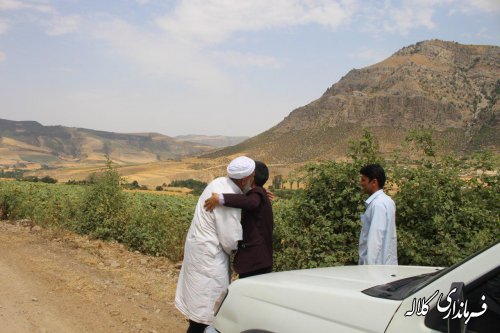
[{"x1": 0, "y1": 0, "x2": 500, "y2": 136}]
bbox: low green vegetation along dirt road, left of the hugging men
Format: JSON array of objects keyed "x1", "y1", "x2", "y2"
[{"x1": 0, "y1": 164, "x2": 197, "y2": 261}]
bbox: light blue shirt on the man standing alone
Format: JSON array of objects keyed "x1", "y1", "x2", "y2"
[{"x1": 359, "y1": 190, "x2": 398, "y2": 265}]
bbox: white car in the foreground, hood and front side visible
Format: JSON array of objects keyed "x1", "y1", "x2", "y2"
[{"x1": 211, "y1": 242, "x2": 500, "y2": 333}]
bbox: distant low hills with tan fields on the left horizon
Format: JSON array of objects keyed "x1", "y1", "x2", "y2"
[{"x1": 0, "y1": 119, "x2": 214, "y2": 166}]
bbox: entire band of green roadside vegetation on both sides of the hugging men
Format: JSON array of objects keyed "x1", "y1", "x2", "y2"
[{"x1": 0, "y1": 130, "x2": 500, "y2": 270}]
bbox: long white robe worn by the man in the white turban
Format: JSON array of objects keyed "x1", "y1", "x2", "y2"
[{"x1": 175, "y1": 177, "x2": 243, "y2": 325}]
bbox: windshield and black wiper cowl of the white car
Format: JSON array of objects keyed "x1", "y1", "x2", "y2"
[{"x1": 363, "y1": 242, "x2": 500, "y2": 300}]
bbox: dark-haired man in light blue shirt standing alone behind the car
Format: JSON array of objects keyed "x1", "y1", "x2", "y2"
[{"x1": 359, "y1": 164, "x2": 398, "y2": 265}]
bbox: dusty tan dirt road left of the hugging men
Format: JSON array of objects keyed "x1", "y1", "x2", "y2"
[{"x1": 0, "y1": 221, "x2": 187, "y2": 333}]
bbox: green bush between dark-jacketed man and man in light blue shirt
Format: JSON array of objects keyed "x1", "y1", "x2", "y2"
[{"x1": 275, "y1": 162, "x2": 363, "y2": 270}]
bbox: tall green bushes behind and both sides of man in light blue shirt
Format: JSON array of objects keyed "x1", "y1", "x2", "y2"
[{"x1": 274, "y1": 130, "x2": 500, "y2": 270}]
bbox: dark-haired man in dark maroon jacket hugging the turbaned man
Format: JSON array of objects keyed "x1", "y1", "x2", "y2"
[{"x1": 205, "y1": 161, "x2": 274, "y2": 279}]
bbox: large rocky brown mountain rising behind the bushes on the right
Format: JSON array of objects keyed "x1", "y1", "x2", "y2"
[{"x1": 204, "y1": 40, "x2": 500, "y2": 163}]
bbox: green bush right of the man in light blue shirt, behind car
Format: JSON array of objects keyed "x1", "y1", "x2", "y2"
[{"x1": 395, "y1": 158, "x2": 500, "y2": 266}]
